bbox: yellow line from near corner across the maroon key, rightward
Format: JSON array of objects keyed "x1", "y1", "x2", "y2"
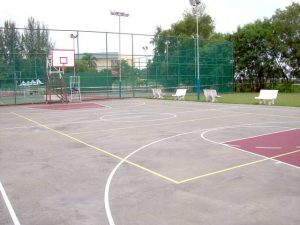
[{"x1": 178, "y1": 149, "x2": 300, "y2": 184}]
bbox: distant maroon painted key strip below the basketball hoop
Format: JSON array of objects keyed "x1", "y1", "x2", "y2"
[{"x1": 31, "y1": 103, "x2": 104, "y2": 110}]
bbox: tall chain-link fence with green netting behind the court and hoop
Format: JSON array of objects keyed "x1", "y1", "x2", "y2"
[{"x1": 0, "y1": 29, "x2": 234, "y2": 105}]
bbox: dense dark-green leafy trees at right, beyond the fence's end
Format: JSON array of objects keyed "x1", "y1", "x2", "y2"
[{"x1": 227, "y1": 3, "x2": 300, "y2": 91}]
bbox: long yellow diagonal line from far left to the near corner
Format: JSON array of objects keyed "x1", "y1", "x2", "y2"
[{"x1": 11, "y1": 112, "x2": 178, "y2": 184}]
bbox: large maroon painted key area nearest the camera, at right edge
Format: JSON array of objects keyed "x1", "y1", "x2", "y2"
[{"x1": 224, "y1": 129, "x2": 300, "y2": 167}]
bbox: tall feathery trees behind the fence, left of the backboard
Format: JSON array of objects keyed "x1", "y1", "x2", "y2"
[{"x1": 0, "y1": 18, "x2": 52, "y2": 86}]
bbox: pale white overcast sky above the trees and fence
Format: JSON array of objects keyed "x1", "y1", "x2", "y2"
[{"x1": 0, "y1": 0, "x2": 300, "y2": 51}]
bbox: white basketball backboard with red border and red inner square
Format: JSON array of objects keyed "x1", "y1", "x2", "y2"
[{"x1": 51, "y1": 49, "x2": 75, "y2": 67}]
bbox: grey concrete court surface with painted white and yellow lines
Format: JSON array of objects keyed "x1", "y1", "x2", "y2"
[{"x1": 0, "y1": 99, "x2": 300, "y2": 225}]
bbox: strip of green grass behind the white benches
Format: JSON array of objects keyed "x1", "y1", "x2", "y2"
[{"x1": 186, "y1": 92, "x2": 300, "y2": 107}]
